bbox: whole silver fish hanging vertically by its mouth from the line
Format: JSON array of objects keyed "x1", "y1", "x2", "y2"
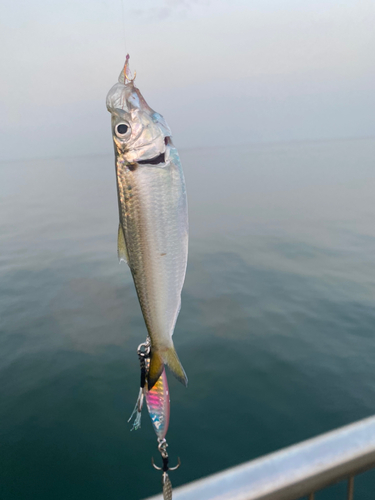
[{"x1": 106, "y1": 55, "x2": 188, "y2": 390}]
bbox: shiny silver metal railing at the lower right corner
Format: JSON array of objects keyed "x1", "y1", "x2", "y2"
[{"x1": 148, "y1": 416, "x2": 375, "y2": 500}]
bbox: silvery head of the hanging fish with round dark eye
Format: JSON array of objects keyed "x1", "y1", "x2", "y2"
[{"x1": 107, "y1": 57, "x2": 172, "y2": 164}]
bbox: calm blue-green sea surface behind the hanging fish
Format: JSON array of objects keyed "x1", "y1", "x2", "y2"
[{"x1": 0, "y1": 140, "x2": 375, "y2": 500}]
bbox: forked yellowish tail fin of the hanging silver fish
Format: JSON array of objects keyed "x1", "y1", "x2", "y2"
[{"x1": 148, "y1": 344, "x2": 188, "y2": 390}]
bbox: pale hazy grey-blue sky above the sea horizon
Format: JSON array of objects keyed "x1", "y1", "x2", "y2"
[{"x1": 0, "y1": 0, "x2": 375, "y2": 159}]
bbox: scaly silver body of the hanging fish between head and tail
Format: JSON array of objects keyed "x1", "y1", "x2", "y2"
[{"x1": 117, "y1": 155, "x2": 188, "y2": 349}]
